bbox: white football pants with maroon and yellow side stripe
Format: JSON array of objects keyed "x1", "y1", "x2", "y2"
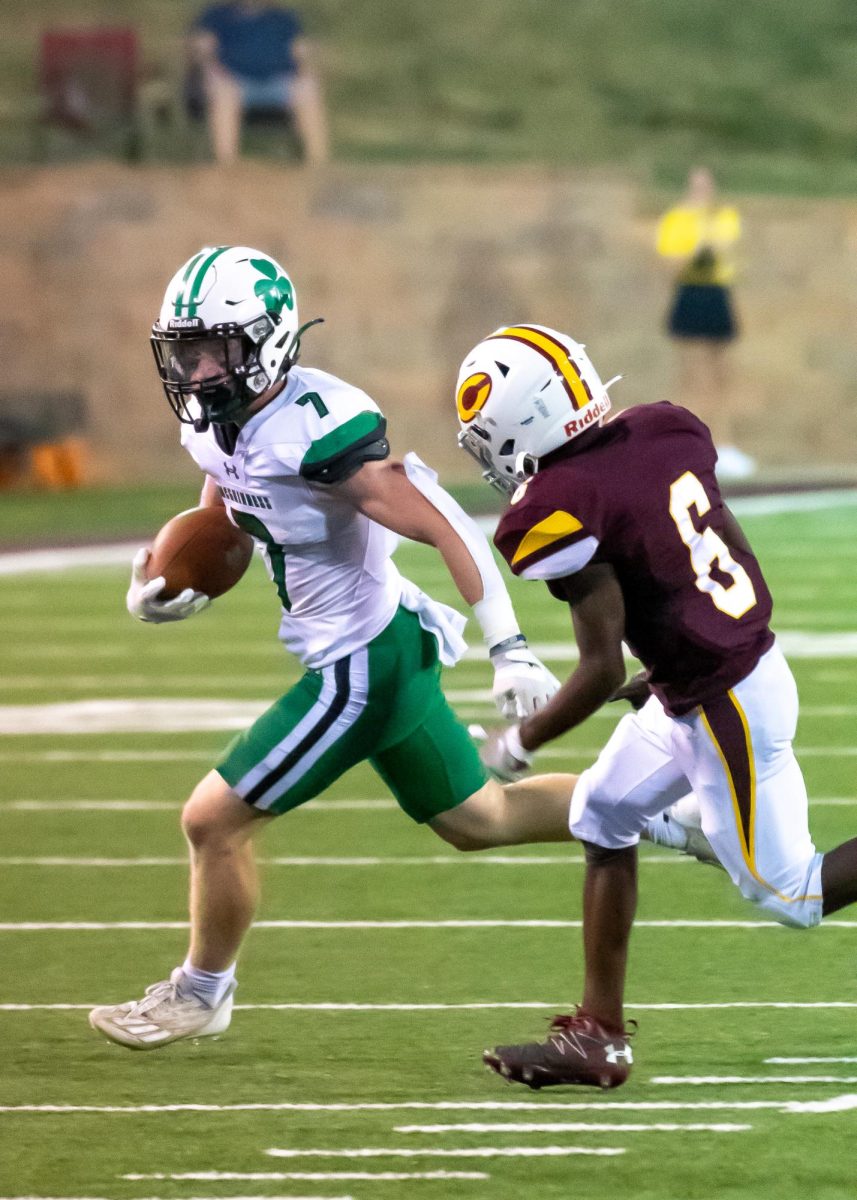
[{"x1": 569, "y1": 646, "x2": 822, "y2": 926}]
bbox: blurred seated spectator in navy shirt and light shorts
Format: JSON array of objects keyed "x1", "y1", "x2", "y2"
[{"x1": 191, "y1": 0, "x2": 328, "y2": 163}]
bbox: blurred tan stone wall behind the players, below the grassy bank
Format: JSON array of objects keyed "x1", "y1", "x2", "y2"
[{"x1": 0, "y1": 162, "x2": 857, "y2": 481}]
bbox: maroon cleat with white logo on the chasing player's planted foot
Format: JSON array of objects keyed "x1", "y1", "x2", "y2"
[{"x1": 483, "y1": 1009, "x2": 634, "y2": 1091}]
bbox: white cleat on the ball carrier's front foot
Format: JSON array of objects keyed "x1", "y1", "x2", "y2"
[{"x1": 89, "y1": 967, "x2": 236, "y2": 1050}]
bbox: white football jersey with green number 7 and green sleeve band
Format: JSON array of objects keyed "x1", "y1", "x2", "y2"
[{"x1": 181, "y1": 366, "x2": 403, "y2": 668}]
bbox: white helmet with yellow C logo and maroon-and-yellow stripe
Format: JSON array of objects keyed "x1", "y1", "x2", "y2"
[{"x1": 455, "y1": 325, "x2": 618, "y2": 493}]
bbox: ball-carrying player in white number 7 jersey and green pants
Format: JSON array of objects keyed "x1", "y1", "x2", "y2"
[{"x1": 90, "y1": 246, "x2": 700, "y2": 1050}]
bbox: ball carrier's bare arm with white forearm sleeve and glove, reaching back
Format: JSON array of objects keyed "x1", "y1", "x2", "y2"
[{"x1": 336, "y1": 455, "x2": 559, "y2": 720}]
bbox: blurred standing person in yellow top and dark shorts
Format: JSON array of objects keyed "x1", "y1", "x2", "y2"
[{"x1": 658, "y1": 167, "x2": 756, "y2": 479}]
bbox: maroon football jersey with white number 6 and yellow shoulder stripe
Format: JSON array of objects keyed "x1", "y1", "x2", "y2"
[{"x1": 495, "y1": 403, "x2": 773, "y2": 716}]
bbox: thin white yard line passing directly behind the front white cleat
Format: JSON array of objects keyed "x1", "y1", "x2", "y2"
[{"x1": 0, "y1": 1000, "x2": 857, "y2": 1017}]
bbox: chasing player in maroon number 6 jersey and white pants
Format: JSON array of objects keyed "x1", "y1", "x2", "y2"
[{"x1": 456, "y1": 325, "x2": 857, "y2": 1088}]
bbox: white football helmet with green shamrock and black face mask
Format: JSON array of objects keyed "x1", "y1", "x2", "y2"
[{"x1": 151, "y1": 246, "x2": 314, "y2": 431}]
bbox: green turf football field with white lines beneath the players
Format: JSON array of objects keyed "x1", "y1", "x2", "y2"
[{"x1": 0, "y1": 497, "x2": 857, "y2": 1200}]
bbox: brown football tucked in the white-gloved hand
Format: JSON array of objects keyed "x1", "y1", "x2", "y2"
[{"x1": 146, "y1": 505, "x2": 253, "y2": 600}]
